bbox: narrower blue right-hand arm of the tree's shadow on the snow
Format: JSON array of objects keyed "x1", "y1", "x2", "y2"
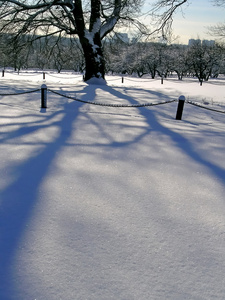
[{"x1": 79, "y1": 82, "x2": 225, "y2": 184}]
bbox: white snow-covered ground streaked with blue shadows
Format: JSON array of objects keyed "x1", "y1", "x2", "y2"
[{"x1": 0, "y1": 72, "x2": 225, "y2": 300}]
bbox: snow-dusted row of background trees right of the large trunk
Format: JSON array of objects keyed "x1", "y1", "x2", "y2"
[{"x1": 105, "y1": 40, "x2": 225, "y2": 82}]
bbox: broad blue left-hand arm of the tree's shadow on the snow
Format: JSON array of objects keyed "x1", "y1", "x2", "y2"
[{"x1": 0, "y1": 99, "x2": 84, "y2": 300}]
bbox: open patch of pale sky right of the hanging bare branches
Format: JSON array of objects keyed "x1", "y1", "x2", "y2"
[{"x1": 173, "y1": 0, "x2": 225, "y2": 44}]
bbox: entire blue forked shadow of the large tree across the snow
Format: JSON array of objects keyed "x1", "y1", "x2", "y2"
[{"x1": 0, "y1": 82, "x2": 225, "y2": 300}]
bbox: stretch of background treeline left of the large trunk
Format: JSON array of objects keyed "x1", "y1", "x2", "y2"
[{"x1": 0, "y1": 34, "x2": 84, "y2": 72}]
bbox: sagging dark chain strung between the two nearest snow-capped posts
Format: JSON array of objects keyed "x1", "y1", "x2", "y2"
[{"x1": 48, "y1": 89, "x2": 176, "y2": 107}]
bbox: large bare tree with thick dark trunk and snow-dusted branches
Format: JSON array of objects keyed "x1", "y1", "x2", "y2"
[{"x1": 0, "y1": 0, "x2": 188, "y2": 81}]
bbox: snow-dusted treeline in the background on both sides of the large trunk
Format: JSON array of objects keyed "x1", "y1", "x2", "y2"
[{"x1": 0, "y1": 34, "x2": 225, "y2": 83}]
